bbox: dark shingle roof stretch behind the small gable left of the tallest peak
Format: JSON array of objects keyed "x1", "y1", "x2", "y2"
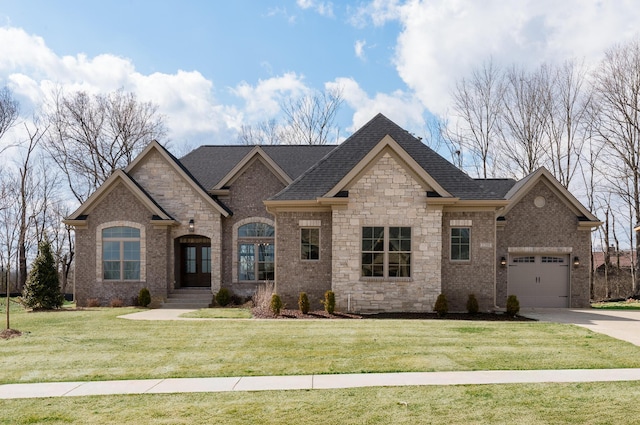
[{"x1": 180, "y1": 145, "x2": 335, "y2": 190}]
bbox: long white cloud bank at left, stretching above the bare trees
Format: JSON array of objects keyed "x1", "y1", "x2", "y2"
[{"x1": 0, "y1": 27, "x2": 240, "y2": 147}]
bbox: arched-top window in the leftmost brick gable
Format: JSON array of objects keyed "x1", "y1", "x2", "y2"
[{"x1": 102, "y1": 226, "x2": 140, "y2": 280}]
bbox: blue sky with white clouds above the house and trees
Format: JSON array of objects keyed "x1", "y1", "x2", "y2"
[{"x1": 0, "y1": 0, "x2": 640, "y2": 153}]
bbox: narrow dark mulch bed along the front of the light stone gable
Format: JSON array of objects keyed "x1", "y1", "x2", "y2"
[{"x1": 251, "y1": 308, "x2": 536, "y2": 322}]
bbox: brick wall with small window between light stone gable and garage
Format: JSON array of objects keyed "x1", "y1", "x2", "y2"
[{"x1": 442, "y1": 210, "x2": 496, "y2": 311}]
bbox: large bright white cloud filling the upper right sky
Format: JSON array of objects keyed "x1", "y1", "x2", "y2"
[{"x1": 351, "y1": 0, "x2": 640, "y2": 114}]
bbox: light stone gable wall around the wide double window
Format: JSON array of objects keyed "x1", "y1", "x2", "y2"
[{"x1": 332, "y1": 153, "x2": 442, "y2": 312}]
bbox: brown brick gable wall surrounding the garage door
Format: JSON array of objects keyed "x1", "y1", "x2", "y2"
[{"x1": 496, "y1": 181, "x2": 591, "y2": 308}]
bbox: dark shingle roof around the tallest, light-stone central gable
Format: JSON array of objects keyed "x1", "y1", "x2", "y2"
[{"x1": 271, "y1": 114, "x2": 501, "y2": 200}]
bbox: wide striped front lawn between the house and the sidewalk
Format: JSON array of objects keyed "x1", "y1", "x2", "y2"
[{"x1": 0, "y1": 306, "x2": 640, "y2": 383}]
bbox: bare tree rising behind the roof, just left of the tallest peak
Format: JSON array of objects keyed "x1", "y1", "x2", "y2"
[{"x1": 280, "y1": 88, "x2": 343, "y2": 145}]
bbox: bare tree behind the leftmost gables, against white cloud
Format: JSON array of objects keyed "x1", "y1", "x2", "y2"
[{"x1": 46, "y1": 90, "x2": 166, "y2": 202}]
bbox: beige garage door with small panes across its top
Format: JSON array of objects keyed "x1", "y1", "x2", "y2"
[{"x1": 508, "y1": 254, "x2": 569, "y2": 307}]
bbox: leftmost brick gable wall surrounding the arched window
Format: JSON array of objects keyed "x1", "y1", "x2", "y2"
[{"x1": 75, "y1": 183, "x2": 169, "y2": 307}]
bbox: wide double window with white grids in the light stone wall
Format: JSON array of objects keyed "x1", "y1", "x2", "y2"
[{"x1": 361, "y1": 226, "x2": 411, "y2": 278}]
